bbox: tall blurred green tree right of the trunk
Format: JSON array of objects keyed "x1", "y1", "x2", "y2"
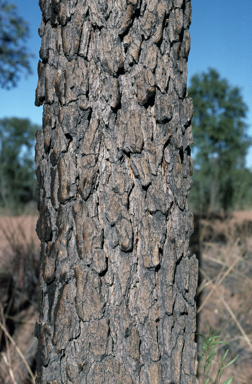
[{"x1": 188, "y1": 68, "x2": 251, "y2": 212}]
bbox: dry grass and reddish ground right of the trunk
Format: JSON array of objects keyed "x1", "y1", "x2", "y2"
[{"x1": 198, "y1": 212, "x2": 252, "y2": 384}]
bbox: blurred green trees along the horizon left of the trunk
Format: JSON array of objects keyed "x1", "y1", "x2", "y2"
[{"x1": 0, "y1": 117, "x2": 40, "y2": 209}]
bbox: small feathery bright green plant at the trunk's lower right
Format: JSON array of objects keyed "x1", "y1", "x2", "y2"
[{"x1": 198, "y1": 328, "x2": 239, "y2": 384}]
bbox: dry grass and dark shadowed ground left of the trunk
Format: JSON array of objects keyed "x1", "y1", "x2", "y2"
[{"x1": 0, "y1": 216, "x2": 39, "y2": 384}]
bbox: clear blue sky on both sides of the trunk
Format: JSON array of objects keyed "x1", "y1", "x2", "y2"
[{"x1": 0, "y1": 0, "x2": 252, "y2": 168}]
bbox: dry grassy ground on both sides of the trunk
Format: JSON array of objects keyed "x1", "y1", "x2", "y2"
[{"x1": 0, "y1": 212, "x2": 252, "y2": 384}]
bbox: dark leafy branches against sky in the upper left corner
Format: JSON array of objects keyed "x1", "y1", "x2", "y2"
[{"x1": 0, "y1": 0, "x2": 33, "y2": 89}]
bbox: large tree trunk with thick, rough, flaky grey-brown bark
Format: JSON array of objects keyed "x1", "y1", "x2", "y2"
[{"x1": 36, "y1": 0, "x2": 197, "y2": 384}]
